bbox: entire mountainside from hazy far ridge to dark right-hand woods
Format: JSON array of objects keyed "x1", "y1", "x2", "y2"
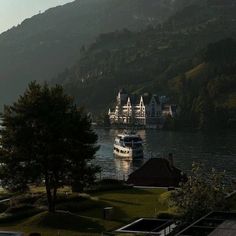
[{"x1": 0, "y1": 0, "x2": 236, "y2": 129}]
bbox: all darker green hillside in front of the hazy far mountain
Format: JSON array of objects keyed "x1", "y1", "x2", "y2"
[{"x1": 53, "y1": 1, "x2": 236, "y2": 129}]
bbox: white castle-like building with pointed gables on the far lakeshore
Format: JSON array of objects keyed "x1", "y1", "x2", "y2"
[{"x1": 108, "y1": 89, "x2": 176, "y2": 125}]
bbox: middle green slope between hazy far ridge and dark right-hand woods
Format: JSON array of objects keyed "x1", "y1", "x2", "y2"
[{"x1": 54, "y1": 1, "x2": 236, "y2": 112}]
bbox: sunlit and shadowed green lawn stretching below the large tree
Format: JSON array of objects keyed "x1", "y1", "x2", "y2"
[{"x1": 0, "y1": 189, "x2": 171, "y2": 236}]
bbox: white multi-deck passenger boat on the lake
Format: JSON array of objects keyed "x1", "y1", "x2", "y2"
[{"x1": 113, "y1": 132, "x2": 143, "y2": 159}]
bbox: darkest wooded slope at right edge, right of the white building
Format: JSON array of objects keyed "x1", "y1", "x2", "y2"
[{"x1": 168, "y1": 39, "x2": 236, "y2": 130}]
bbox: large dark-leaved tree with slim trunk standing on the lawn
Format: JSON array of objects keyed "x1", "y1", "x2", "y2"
[{"x1": 0, "y1": 82, "x2": 98, "y2": 212}]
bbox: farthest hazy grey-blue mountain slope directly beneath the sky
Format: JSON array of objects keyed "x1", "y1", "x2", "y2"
[{"x1": 0, "y1": 0, "x2": 189, "y2": 104}]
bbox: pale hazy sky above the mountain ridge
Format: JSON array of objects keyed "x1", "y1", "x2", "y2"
[{"x1": 0, "y1": 0, "x2": 73, "y2": 33}]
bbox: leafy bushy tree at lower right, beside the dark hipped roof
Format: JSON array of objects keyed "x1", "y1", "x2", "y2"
[{"x1": 171, "y1": 163, "x2": 227, "y2": 222}]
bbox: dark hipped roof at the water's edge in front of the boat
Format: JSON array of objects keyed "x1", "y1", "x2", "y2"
[{"x1": 127, "y1": 158, "x2": 186, "y2": 187}]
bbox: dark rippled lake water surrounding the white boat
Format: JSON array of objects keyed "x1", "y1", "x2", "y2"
[{"x1": 96, "y1": 129, "x2": 236, "y2": 179}]
